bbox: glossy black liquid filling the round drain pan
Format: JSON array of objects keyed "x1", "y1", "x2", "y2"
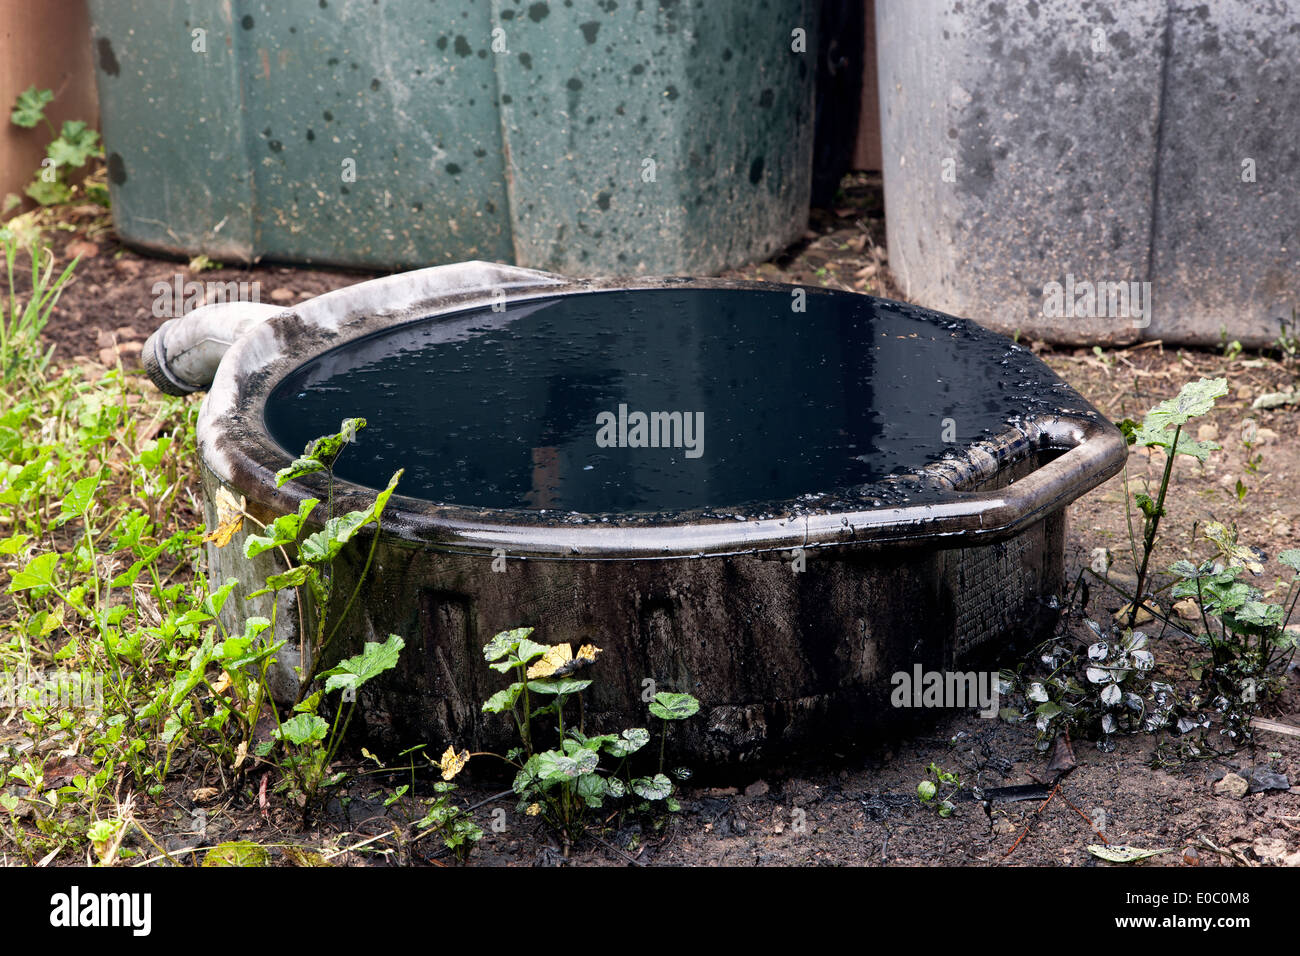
[{"x1": 265, "y1": 286, "x2": 1058, "y2": 514}]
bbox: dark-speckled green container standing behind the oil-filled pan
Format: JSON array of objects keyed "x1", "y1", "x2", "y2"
[{"x1": 83, "y1": 0, "x2": 818, "y2": 274}]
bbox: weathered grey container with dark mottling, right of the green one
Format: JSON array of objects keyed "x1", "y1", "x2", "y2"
[{"x1": 876, "y1": 0, "x2": 1300, "y2": 345}]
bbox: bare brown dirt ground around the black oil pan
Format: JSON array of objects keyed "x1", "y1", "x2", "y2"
[{"x1": 17, "y1": 174, "x2": 1300, "y2": 866}]
